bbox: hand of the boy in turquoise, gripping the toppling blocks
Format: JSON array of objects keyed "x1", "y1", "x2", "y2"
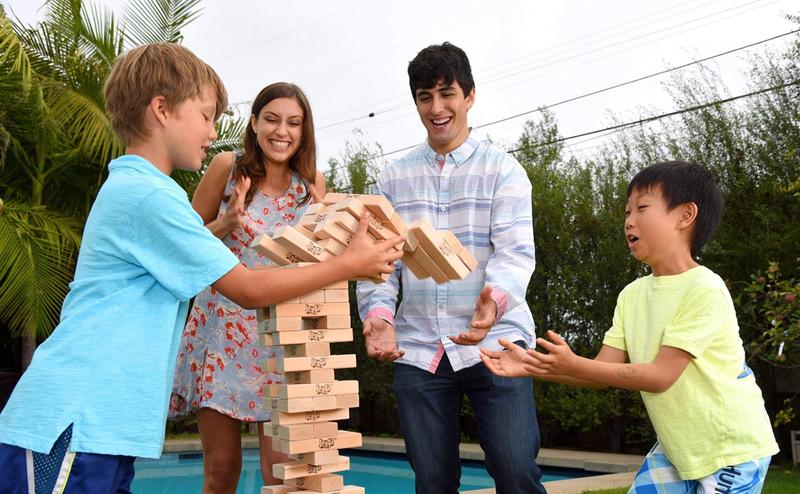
[{"x1": 339, "y1": 214, "x2": 405, "y2": 279}]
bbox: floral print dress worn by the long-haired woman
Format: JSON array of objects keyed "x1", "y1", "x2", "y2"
[{"x1": 169, "y1": 159, "x2": 306, "y2": 422}]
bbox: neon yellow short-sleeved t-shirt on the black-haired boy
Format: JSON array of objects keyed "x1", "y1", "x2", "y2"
[{"x1": 603, "y1": 266, "x2": 778, "y2": 480}]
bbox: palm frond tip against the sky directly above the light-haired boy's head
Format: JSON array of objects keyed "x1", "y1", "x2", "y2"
[{"x1": 124, "y1": 0, "x2": 200, "y2": 46}]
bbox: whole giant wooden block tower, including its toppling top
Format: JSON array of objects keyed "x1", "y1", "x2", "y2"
[{"x1": 253, "y1": 193, "x2": 477, "y2": 494}]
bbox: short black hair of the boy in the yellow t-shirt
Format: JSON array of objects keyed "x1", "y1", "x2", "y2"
[{"x1": 628, "y1": 161, "x2": 724, "y2": 257}]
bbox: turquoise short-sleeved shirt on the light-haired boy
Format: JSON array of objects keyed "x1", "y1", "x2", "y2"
[{"x1": 0, "y1": 155, "x2": 239, "y2": 458}]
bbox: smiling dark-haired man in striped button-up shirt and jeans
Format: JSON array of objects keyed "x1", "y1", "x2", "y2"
[{"x1": 358, "y1": 43, "x2": 544, "y2": 494}]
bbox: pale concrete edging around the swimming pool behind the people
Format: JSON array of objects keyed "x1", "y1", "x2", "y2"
[{"x1": 164, "y1": 436, "x2": 644, "y2": 494}]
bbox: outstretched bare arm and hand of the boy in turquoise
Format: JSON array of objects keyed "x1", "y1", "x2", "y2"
[{"x1": 213, "y1": 217, "x2": 403, "y2": 309}]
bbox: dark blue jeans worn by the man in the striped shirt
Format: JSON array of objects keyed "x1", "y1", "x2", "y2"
[{"x1": 394, "y1": 346, "x2": 545, "y2": 494}]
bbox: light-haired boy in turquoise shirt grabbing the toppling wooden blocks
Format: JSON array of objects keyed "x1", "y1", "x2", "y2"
[{"x1": 0, "y1": 43, "x2": 402, "y2": 494}]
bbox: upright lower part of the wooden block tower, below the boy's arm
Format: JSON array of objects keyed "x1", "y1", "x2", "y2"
[{"x1": 258, "y1": 274, "x2": 364, "y2": 494}]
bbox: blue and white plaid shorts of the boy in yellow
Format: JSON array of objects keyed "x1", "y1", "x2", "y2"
[{"x1": 628, "y1": 442, "x2": 772, "y2": 494}]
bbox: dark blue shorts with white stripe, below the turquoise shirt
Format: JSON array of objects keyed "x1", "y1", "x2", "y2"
[{"x1": 0, "y1": 425, "x2": 135, "y2": 494}]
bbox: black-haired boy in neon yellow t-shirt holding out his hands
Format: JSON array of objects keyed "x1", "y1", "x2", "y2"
[{"x1": 483, "y1": 161, "x2": 778, "y2": 494}]
